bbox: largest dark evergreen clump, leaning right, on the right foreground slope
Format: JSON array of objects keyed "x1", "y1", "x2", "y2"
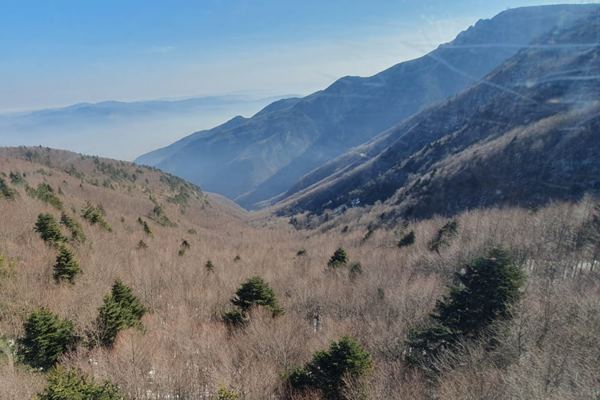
[{"x1": 407, "y1": 249, "x2": 524, "y2": 367}]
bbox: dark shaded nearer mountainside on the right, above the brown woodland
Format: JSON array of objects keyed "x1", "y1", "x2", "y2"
[{"x1": 282, "y1": 12, "x2": 600, "y2": 217}]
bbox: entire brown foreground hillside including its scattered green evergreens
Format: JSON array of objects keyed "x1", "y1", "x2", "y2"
[{"x1": 0, "y1": 148, "x2": 600, "y2": 400}]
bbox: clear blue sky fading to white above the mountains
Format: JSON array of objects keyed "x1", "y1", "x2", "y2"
[{"x1": 0, "y1": 0, "x2": 589, "y2": 110}]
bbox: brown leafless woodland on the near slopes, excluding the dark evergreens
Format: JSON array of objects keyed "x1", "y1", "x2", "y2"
[{"x1": 0, "y1": 148, "x2": 600, "y2": 399}]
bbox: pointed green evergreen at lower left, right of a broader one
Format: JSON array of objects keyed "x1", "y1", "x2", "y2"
[{"x1": 96, "y1": 280, "x2": 146, "y2": 347}]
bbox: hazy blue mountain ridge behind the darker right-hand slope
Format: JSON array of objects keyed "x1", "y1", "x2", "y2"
[{"x1": 136, "y1": 5, "x2": 596, "y2": 208}]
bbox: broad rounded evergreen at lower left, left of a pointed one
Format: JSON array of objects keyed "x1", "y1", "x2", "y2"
[{"x1": 17, "y1": 309, "x2": 77, "y2": 370}]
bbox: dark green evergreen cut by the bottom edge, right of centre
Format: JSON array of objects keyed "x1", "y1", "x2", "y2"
[{"x1": 288, "y1": 336, "x2": 373, "y2": 400}]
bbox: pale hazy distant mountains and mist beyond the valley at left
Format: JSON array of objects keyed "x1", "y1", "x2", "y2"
[{"x1": 0, "y1": 96, "x2": 280, "y2": 160}]
